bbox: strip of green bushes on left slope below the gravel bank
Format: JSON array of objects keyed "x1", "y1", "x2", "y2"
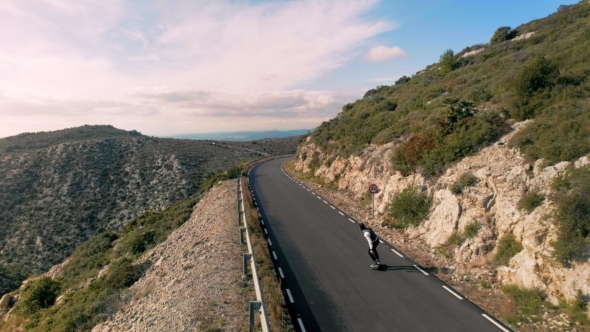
[{"x1": 0, "y1": 164, "x2": 242, "y2": 331}]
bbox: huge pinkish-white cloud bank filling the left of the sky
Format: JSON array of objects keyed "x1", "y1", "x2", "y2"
[{"x1": 0, "y1": 0, "x2": 403, "y2": 137}]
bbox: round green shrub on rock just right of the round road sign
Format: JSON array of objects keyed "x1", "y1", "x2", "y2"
[{"x1": 388, "y1": 187, "x2": 432, "y2": 228}]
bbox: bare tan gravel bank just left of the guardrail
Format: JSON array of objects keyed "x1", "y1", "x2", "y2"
[{"x1": 92, "y1": 180, "x2": 254, "y2": 332}]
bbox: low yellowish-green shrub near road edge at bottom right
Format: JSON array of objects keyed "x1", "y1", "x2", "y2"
[{"x1": 502, "y1": 285, "x2": 543, "y2": 326}]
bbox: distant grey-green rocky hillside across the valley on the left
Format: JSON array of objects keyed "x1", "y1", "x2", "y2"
[{"x1": 0, "y1": 126, "x2": 296, "y2": 294}]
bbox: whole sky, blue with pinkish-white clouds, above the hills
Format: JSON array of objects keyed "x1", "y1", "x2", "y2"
[{"x1": 0, "y1": 0, "x2": 577, "y2": 137}]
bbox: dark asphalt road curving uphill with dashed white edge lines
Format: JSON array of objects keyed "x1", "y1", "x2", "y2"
[{"x1": 249, "y1": 158, "x2": 510, "y2": 332}]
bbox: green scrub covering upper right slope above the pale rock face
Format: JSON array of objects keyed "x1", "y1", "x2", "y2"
[{"x1": 311, "y1": 2, "x2": 590, "y2": 174}]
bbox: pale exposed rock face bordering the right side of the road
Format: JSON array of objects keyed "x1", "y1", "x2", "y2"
[{"x1": 295, "y1": 121, "x2": 590, "y2": 331}]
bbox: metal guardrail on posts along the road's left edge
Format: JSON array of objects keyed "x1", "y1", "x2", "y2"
[{"x1": 238, "y1": 154, "x2": 292, "y2": 332}]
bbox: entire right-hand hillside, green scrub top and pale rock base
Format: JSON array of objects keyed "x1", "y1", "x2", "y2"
[{"x1": 296, "y1": 1, "x2": 590, "y2": 331}]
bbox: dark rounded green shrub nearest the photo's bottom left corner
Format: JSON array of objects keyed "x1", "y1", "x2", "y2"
[{"x1": 18, "y1": 277, "x2": 60, "y2": 316}]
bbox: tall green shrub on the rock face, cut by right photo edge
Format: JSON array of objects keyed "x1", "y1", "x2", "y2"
[{"x1": 553, "y1": 167, "x2": 590, "y2": 265}]
